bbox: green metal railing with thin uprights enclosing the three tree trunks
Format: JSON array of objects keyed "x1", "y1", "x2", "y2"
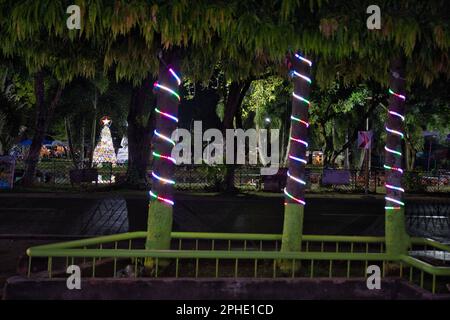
[{"x1": 27, "y1": 232, "x2": 450, "y2": 293}]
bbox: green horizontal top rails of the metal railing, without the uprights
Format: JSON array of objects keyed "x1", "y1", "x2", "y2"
[{"x1": 27, "y1": 231, "x2": 450, "y2": 276}]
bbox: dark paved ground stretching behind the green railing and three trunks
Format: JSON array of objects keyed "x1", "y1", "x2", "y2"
[{"x1": 0, "y1": 193, "x2": 450, "y2": 296}]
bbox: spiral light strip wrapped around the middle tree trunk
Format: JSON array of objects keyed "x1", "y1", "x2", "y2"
[{"x1": 284, "y1": 53, "x2": 312, "y2": 206}]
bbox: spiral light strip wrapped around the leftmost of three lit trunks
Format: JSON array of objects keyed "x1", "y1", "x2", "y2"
[{"x1": 149, "y1": 65, "x2": 181, "y2": 206}]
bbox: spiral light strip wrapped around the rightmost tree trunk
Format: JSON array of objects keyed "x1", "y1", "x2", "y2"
[{"x1": 384, "y1": 88, "x2": 406, "y2": 210}]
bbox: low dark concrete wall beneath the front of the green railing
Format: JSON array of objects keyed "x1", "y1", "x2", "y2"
[{"x1": 3, "y1": 277, "x2": 450, "y2": 300}]
